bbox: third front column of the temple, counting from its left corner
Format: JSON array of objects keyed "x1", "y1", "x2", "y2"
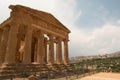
[{"x1": 37, "y1": 32, "x2": 45, "y2": 64}]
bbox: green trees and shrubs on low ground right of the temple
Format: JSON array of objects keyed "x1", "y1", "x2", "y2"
[{"x1": 72, "y1": 57, "x2": 120, "y2": 73}]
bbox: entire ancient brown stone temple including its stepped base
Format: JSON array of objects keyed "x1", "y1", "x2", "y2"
[{"x1": 0, "y1": 5, "x2": 71, "y2": 76}]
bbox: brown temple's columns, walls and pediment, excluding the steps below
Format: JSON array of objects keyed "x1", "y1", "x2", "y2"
[{"x1": 0, "y1": 5, "x2": 70, "y2": 65}]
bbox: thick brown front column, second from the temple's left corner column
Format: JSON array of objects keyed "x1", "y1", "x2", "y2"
[{"x1": 23, "y1": 26, "x2": 33, "y2": 64}]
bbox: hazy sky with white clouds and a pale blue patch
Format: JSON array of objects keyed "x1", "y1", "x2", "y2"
[{"x1": 0, "y1": 0, "x2": 120, "y2": 56}]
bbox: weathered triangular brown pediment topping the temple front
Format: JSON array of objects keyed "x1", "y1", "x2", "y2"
[{"x1": 10, "y1": 5, "x2": 70, "y2": 33}]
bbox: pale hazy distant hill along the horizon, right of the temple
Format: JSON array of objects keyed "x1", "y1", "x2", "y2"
[{"x1": 70, "y1": 51, "x2": 120, "y2": 62}]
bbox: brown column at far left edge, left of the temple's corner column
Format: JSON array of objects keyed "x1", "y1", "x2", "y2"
[{"x1": 0, "y1": 26, "x2": 9, "y2": 64}]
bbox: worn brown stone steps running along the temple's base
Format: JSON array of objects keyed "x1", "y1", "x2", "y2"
[{"x1": 0, "y1": 64, "x2": 72, "y2": 78}]
